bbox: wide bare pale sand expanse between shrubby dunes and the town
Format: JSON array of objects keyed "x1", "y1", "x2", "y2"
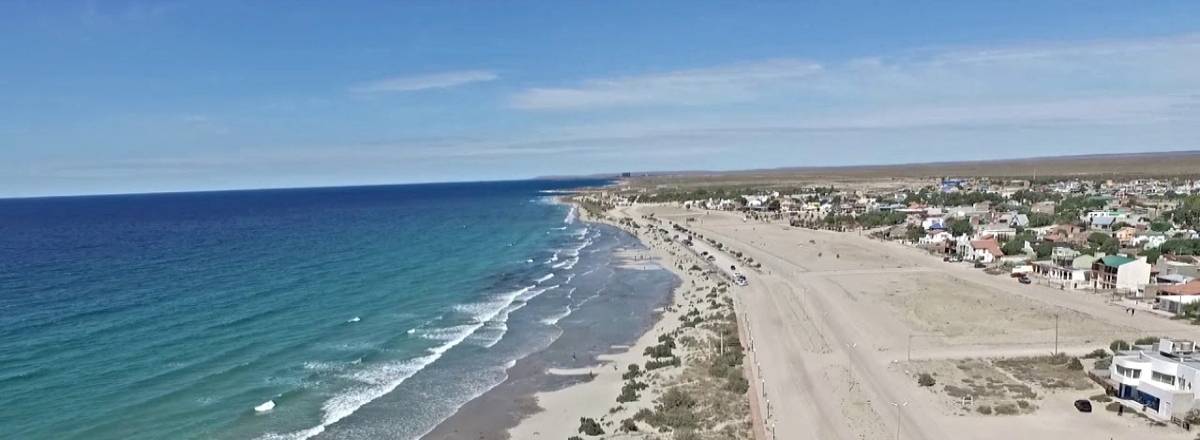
[{"x1": 617, "y1": 205, "x2": 1200, "y2": 440}]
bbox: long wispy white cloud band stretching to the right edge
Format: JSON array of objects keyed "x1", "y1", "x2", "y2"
[{"x1": 511, "y1": 35, "x2": 1200, "y2": 115}]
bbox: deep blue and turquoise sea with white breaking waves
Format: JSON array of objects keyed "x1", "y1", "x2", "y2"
[{"x1": 0, "y1": 181, "x2": 661, "y2": 439}]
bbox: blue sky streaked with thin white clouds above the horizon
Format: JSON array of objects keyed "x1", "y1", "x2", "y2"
[{"x1": 0, "y1": 0, "x2": 1200, "y2": 197}]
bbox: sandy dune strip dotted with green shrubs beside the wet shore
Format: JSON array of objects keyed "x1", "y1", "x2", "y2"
[{"x1": 552, "y1": 208, "x2": 754, "y2": 440}]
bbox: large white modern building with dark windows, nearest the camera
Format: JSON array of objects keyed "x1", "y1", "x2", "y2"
[{"x1": 1109, "y1": 338, "x2": 1200, "y2": 421}]
